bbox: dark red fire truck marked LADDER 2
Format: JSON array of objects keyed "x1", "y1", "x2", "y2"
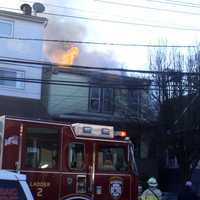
[{"x1": 0, "y1": 116, "x2": 138, "y2": 200}]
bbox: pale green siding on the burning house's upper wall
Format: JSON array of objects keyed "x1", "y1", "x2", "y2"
[{"x1": 48, "y1": 73, "x2": 89, "y2": 115}]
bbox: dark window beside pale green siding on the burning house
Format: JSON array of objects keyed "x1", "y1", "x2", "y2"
[{"x1": 89, "y1": 87, "x2": 114, "y2": 113}]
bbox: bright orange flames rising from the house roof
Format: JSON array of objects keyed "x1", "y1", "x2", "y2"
[{"x1": 50, "y1": 46, "x2": 79, "y2": 65}]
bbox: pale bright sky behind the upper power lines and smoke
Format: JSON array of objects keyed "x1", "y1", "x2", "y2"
[{"x1": 0, "y1": 0, "x2": 200, "y2": 70}]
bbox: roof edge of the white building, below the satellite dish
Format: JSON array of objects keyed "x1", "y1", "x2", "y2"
[{"x1": 0, "y1": 10, "x2": 48, "y2": 24}]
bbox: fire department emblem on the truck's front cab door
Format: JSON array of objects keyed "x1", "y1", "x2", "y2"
[{"x1": 110, "y1": 179, "x2": 123, "y2": 199}]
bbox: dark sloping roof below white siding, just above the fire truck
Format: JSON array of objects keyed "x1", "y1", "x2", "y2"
[{"x1": 0, "y1": 96, "x2": 50, "y2": 119}]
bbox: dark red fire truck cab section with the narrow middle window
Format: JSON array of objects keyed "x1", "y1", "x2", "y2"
[{"x1": 60, "y1": 137, "x2": 94, "y2": 199}]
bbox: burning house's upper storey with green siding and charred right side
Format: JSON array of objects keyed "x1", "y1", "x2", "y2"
[{"x1": 43, "y1": 66, "x2": 151, "y2": 124}]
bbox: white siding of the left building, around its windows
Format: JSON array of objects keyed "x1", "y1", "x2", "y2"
[{"x1": 0, "y1": 16, "x2": 44, "y2": 99}]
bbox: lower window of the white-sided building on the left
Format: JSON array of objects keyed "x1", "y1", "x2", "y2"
[{"x1": 0, "y1": 69, "x2": 24, "y2": 89}]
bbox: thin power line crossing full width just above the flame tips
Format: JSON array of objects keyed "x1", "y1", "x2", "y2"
[{"x1": 0, "y1": 35, "x2": 197, "y2": 48}]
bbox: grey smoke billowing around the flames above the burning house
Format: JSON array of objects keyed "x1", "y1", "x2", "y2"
[{"x1": 44, "y1": 11, "x2": 122, "y2": 68}]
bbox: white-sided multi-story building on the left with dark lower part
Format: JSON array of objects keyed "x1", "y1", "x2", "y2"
[{"x1": 0, "y1": 7, "x2": 47, "y2": 117}]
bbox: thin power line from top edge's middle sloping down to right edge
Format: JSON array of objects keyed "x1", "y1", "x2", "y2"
[{"x1": 94, "y1": 0, "x2": 200, "y2": 16}]
